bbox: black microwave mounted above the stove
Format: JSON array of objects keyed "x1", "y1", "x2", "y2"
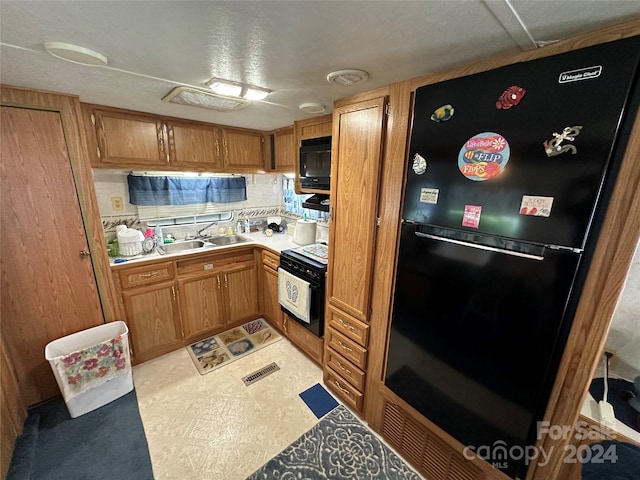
[{"x1": 299, "y1": 136, "x2": 331, "y2": 190}]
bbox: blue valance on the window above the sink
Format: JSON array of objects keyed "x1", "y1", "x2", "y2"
[{"x1": 127, "y1": 174, "x2": 247, "y2": 206}]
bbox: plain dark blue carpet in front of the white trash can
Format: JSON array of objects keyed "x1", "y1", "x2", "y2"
[{"x1": 7, "y1": 390, "x2": 153, "y2": 480}]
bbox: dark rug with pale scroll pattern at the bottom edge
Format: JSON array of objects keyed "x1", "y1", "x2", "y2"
[{"x1": 247, "y1": 405, "x2": 420, "y2": 480}]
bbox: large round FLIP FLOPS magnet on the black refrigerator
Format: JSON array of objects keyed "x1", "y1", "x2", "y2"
[{"x1": 458, "y1": 132, "x2": 511, "y2": 182}]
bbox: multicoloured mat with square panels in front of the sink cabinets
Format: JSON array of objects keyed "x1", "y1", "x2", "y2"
[{"x1": 187, "y1": 318, "x2": 282, "y2": 375}]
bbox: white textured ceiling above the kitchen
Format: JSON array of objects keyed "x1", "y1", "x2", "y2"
[{"x1": 0, "y1": 0, "x2": 640, "y2": 130}]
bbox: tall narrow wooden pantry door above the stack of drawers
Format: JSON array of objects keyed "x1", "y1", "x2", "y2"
[{"x1": 327, "y1": 97, "x2": 385, "y2": 321}]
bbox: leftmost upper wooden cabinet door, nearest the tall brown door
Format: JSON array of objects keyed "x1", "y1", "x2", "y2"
[{"x1": 92, "y1": 109, "x2": 168, "y2": 167}]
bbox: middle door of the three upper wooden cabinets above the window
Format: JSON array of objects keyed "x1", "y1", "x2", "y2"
[{"x1": 166, "y1": 122, "x2": 222, "y2": 170}]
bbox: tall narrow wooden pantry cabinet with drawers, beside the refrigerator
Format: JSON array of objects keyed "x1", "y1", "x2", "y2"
[{"x1": 323, "y1": 96, "x2": 387, "y2": 412}]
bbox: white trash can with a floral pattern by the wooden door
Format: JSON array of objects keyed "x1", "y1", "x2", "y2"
[{"x1": 44, "y1": 321, "x2": 133, "y2": 418}]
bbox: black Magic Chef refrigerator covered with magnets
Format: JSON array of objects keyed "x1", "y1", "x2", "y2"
[{"x1": 385, "y1": 37, "x2": 640, "y2": 478}]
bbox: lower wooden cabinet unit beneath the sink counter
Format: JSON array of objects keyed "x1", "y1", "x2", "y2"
[{"x1": 114, "y1": 249, "x2": 260, "y2": 363}]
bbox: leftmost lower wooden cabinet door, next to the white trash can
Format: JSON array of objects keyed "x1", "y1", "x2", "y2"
[{"x1": 122, "y1": 282, "x2": 182, "y2": 362}]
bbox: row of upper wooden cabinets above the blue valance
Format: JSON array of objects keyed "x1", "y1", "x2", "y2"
[{"x1": 81, "y1": 104, "x2": 266, "y2": 173}]
